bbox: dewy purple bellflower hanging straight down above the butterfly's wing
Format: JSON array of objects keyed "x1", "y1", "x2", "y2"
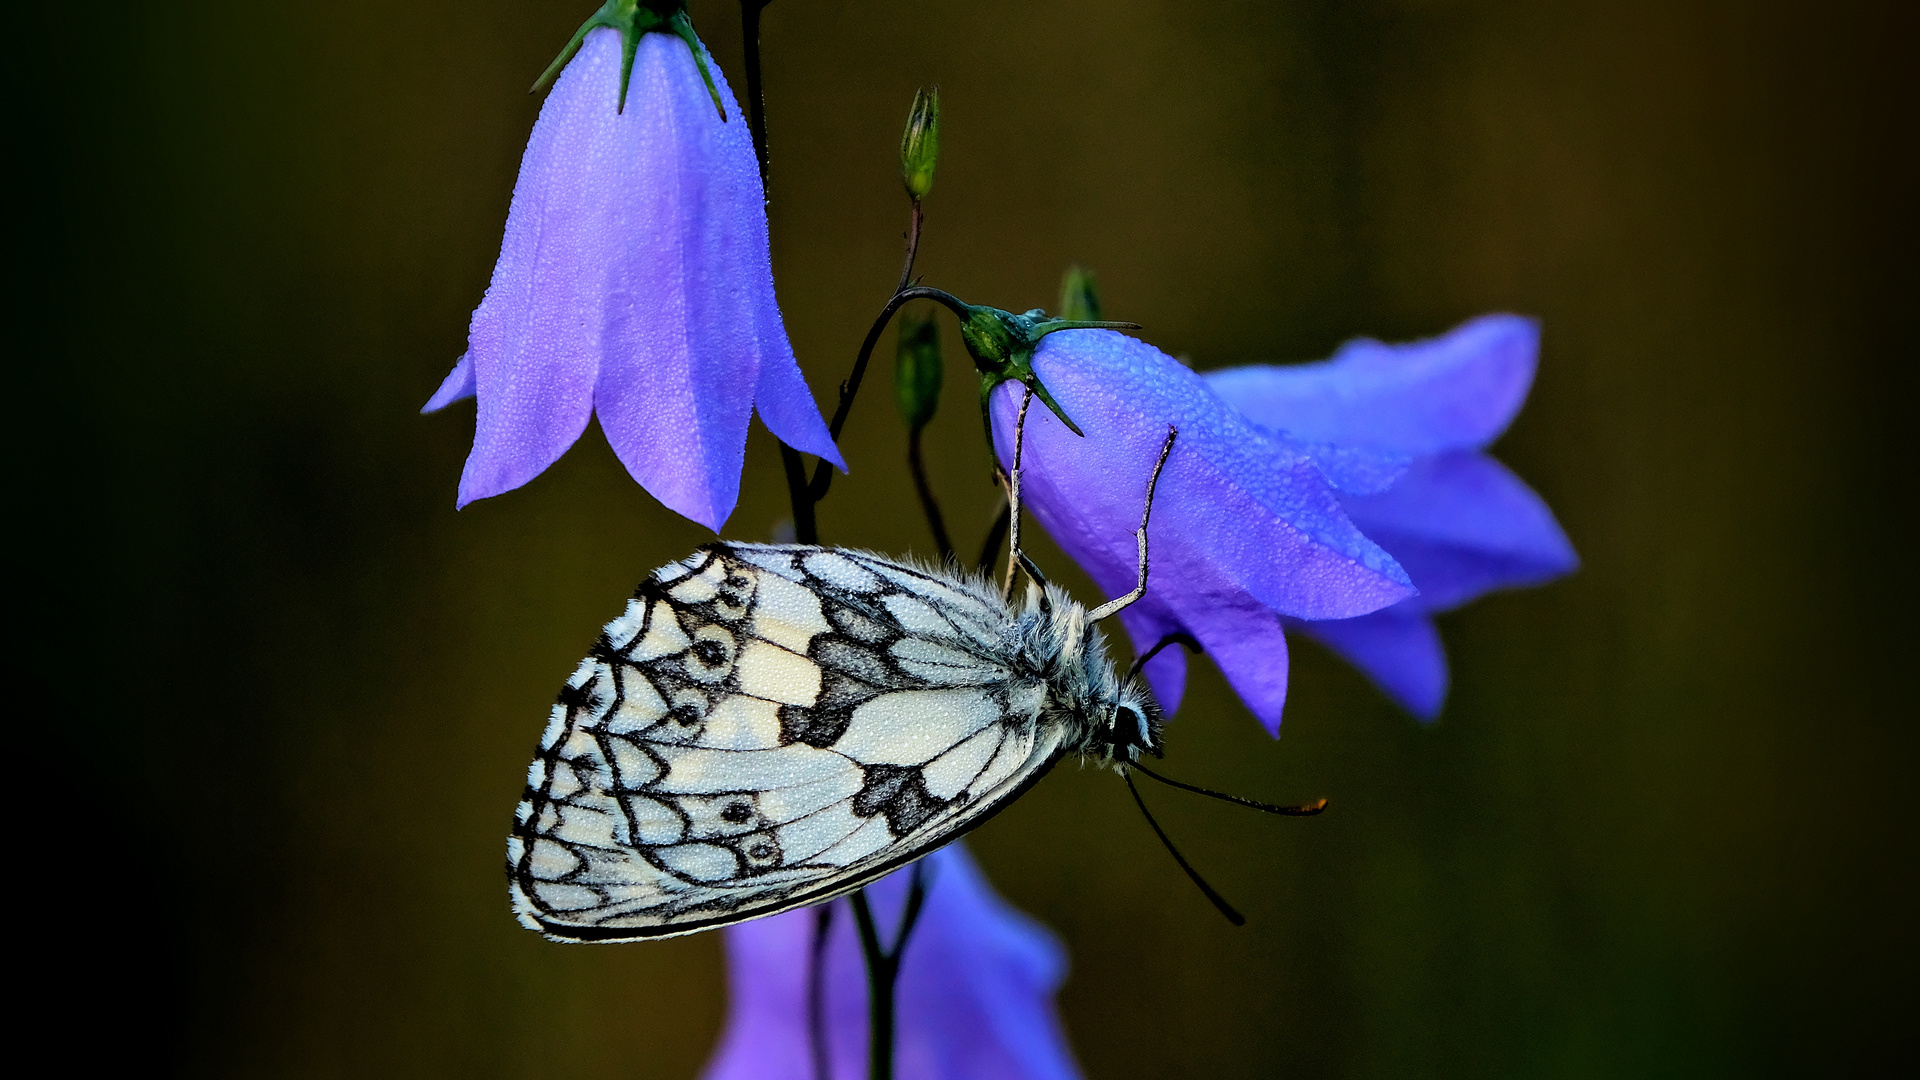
[{"x1": 422, "y1": 29, "x2": 845, "y2": 530}]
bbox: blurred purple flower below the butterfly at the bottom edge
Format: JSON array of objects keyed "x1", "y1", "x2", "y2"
[{"x1": 705, "y1": 844, "x2": 1079, "y2": 1080}]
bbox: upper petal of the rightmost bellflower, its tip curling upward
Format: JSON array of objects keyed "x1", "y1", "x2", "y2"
[{"x1": 1206, "y1": 315, "x2": 1540, "y2": 457}]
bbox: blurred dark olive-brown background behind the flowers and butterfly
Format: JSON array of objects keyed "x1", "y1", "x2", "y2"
[{"x1": 22, "y1": 0, "x2": 1920, "y2": 1078}]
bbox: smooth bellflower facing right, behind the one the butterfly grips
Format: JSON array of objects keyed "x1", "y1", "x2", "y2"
[{"x1": 1213, "y1": 315, "x2": 1580, "y2": 721}]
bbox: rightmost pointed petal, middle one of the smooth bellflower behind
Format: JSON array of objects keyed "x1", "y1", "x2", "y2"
[{"x1": 1342, "y1": 452, "x2": 1580, "y2": 611}]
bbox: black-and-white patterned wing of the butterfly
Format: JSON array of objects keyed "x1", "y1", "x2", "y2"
[{"x1": 507, "y1": 544, "x2": 1062, "y2": 942}]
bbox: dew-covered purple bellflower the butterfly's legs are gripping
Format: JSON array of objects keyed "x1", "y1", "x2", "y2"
[{"x1": 993, "y1": 331, "x2": 1415, "y2": 732}]
